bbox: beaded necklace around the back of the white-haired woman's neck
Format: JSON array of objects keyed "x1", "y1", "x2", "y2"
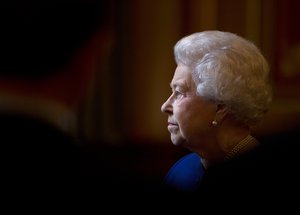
[{"x1": 225, "y1": 135, "x2": 259, "y2": 160}]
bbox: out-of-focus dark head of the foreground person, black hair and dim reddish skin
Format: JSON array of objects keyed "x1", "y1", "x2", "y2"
[{"x1": 0, "y1": 0, "x2": 112, "y2": 105}]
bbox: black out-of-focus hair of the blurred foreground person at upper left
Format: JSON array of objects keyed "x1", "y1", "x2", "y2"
[{"x1": 0, "y1": 0, "x2": 111, "y2": 79}]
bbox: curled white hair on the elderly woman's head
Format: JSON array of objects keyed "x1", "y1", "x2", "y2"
[{"x1": 174, "y1": 31, "x2": 272, "y2": 125}]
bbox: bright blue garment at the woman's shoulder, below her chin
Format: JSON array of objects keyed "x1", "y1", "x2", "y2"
[{"x1": 164, "y1": 153, "x2": 204, "y2": 192}]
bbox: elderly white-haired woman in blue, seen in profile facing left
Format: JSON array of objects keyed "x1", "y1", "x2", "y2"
[{"x1": 161, "y1": 31, "x2": 296, "y2": 197}]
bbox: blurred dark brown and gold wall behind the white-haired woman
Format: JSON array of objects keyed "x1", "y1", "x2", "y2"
[{"x1": 2, "y1": 0, "x2": 300, "y2": 183}]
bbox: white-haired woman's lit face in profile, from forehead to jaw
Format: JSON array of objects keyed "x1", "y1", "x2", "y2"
[{"x1": 161, "y1": 65, "x2": 216, "y2": 149}]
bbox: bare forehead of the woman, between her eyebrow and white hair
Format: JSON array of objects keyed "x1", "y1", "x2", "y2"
[{"x1": 171, "y1": 65, "x2": 194, "y2": 88}]
